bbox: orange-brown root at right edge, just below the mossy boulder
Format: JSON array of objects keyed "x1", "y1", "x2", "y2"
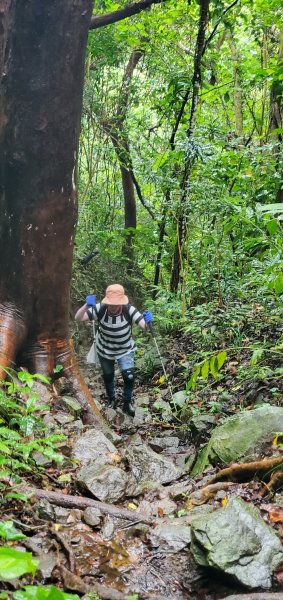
[{"x1": 208, "y1": 456, "x2": 283, "y2": 485}]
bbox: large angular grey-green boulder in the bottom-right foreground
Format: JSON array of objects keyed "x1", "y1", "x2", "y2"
[{"x1": 191, "y1": 498, "x2": 283, "y2": 588}]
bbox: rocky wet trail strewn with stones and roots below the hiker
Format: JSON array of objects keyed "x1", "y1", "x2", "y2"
[{"x1": 2, "y1": 350, "x2": 283, "y2": 600}]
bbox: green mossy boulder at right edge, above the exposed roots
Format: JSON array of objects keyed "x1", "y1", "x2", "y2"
[{"x1": 191, "y1": 406, "x2": 283, "y2": 476}]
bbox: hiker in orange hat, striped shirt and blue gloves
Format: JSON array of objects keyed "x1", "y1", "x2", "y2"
[{"x1": 75, "y1": 283, "x2": 153, "y2": 417}]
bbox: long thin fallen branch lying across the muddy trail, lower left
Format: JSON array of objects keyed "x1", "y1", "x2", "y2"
[{"x1": 20, "y1": 487, "x2": 152, "y2": 523}]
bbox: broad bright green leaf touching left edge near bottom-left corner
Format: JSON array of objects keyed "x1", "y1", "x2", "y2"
[{"x1": 0, "y1": 548, "x2": 39, "y2": 581}]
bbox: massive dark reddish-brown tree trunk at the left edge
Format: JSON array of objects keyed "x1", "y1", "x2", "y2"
[{"x1": 0, "y1": 0, "x2": 107, "y2": 432}]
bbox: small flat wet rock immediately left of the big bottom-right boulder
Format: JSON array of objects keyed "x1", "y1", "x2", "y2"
[{"x1": 149, "y1": 523, "x2": 191, "y2": 552}]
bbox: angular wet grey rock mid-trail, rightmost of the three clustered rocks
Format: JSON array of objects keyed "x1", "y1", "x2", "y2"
[{"x1": 125, "y1": 444, "x2": 181, "y2": 483}]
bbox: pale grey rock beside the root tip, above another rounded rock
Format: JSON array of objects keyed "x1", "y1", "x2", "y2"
[{"x1": 72, "y1": 429, "x2": 117, "y2": 465}]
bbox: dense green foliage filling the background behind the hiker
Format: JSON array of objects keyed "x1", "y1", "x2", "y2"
[{"x1": 75, "y1": 0, "x2": 283, "y2": 320}]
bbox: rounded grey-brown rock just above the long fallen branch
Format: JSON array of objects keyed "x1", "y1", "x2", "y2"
[{"x1": 77, "y1": 464, "x2": 128, "y2": 502}]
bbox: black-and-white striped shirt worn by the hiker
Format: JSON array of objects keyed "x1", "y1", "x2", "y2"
[{"x1": 88, "y1": 303, "x2": 143, "y2": 360}]
